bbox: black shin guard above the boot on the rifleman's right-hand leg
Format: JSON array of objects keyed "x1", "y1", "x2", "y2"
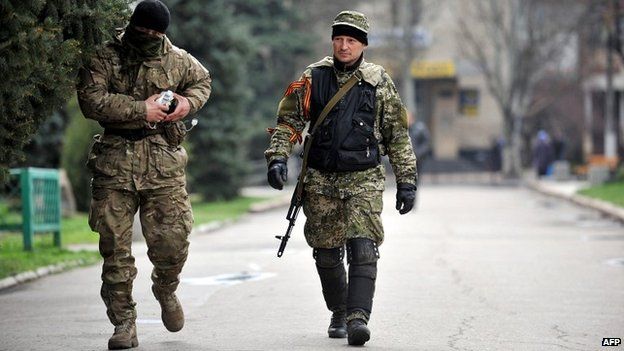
[{"x1": 347, "y1": 239, "x2": 379, "y2": 318}]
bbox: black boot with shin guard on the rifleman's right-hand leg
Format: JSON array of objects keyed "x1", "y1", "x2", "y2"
[{"x1": 347, "y1": 239, "x2": 379, "y2": 346}]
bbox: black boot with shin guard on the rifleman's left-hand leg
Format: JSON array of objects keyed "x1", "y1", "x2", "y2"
[{"x1": 313, "y1": 247, "x2": 347, "y2": 338}]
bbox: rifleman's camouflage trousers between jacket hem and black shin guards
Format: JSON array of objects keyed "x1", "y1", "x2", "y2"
[{"x1": 303, "y1": 191, "x2": 384, "y2": 249}]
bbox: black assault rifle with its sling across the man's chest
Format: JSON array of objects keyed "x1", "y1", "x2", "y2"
[{"x1": 275, "y1": 73, "x2": 361, "y2": 257}]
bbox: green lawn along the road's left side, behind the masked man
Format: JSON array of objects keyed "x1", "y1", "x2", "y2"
[{"x1": 0, "y1": 197, "x2": 265, "y2": 279}]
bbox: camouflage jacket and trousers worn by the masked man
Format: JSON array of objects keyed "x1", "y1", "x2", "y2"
[{"x1": 77, "y1": 32, "x2": 211, "y2": 325}]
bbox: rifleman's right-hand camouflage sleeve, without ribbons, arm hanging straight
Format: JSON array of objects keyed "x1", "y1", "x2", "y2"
[{"x1": 378, "y1": 73, "x2": 417, "y2": 185}]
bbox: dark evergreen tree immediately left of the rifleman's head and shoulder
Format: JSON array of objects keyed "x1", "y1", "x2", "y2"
[{"x1": 234, "y1": 0, "x2": 316, "y2": 160}]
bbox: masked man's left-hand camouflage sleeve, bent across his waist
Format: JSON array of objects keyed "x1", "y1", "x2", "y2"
[{"x1": 77, "y1": 51, "x2": 147, "y2": 122}]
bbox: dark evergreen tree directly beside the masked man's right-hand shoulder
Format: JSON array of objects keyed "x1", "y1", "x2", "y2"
[{"x1": 166, "y1": 0, "x2": 252, "y2": 199}]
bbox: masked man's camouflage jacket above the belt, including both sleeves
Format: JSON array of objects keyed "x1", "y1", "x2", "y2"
[{"x1": 77, "y1": 36, "x2": 211, "y2": 129}]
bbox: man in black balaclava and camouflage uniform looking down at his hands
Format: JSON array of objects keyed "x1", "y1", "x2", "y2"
[{"x1": 77, "y1": 0, "x2": 211, "y2": 349}]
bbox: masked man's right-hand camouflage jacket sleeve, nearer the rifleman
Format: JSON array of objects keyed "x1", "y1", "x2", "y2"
[{"x1": 180, "y1": 54, "x2": 212, "y2": 115}]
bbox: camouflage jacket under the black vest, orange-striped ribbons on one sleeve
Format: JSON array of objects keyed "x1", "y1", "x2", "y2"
[{"x1": 265, "y1": 57, "x2": 417, "y2": 198}]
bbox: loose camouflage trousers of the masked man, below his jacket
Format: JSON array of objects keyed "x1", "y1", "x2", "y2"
[{"x1": 89, "y1": 186, "x2": 193, "y2": 325}]
